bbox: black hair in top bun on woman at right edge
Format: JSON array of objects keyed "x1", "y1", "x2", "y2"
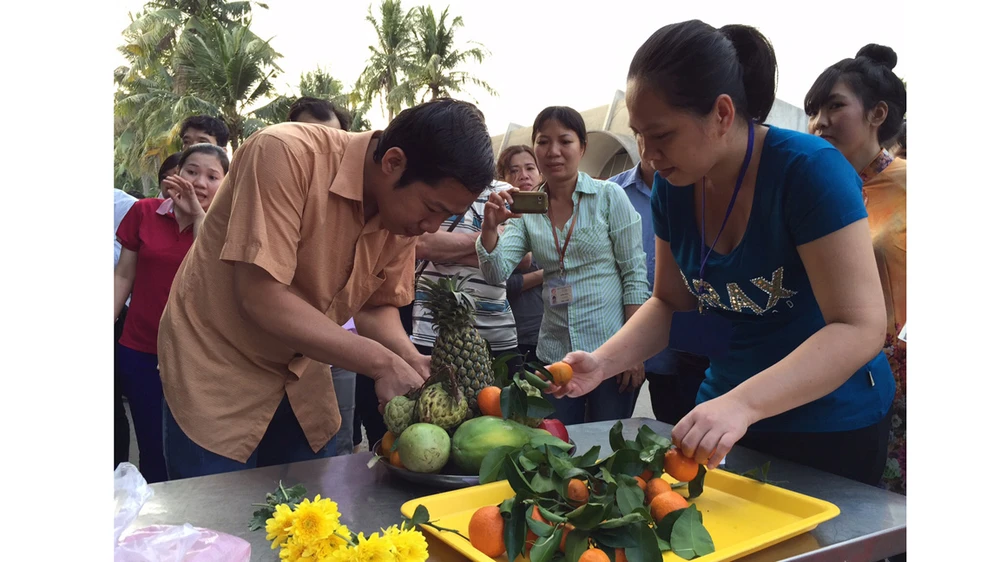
[{"x1": 804, "y1": 43, "x2": 906, "y2": 144}]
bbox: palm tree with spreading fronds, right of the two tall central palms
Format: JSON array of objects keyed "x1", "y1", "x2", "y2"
[{"x1": 389, "y1": 6, "x2": 497, "y2": 105}]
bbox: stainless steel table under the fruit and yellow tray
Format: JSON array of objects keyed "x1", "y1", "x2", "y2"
[{"x1": 129, "y1": 418, "x2": 906, "y2": 562}]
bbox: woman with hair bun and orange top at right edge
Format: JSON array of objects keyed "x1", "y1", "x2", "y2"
[{"x1": 805, "y1": 44, "x2": 906, "y2": 493}]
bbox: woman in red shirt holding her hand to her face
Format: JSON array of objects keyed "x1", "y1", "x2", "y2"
[{"x1": 115, "y1": 144, "x2": 229, "y2": 483}]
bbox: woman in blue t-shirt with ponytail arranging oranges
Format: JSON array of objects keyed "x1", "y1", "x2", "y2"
[{"x1": 552, "y1": 21, "x2": 895, "y2": 484}]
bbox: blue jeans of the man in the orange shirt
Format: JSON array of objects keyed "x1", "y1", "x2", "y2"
[{"x1": 163, "y1": 396, "x2": 337, "y2": 480}]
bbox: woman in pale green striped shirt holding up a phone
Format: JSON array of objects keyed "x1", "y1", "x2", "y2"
[{"x1": 476, "y1": 107, "x2": 649, "y2": 425}]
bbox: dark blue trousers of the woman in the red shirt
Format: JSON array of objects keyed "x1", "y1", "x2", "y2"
[{"x1": 115, "y1": 343, "x2": 167, "y2": 484}]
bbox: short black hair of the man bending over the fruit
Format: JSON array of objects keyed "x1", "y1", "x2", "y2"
[{"x1": 374, "y1": 98, "x2": 494, "y2": 194}]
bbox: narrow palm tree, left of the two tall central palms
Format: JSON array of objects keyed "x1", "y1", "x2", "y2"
[{"x1": 354, "y1": 0, "x2": 413, "y2": 121}]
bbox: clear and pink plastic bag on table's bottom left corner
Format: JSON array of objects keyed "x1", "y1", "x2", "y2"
[{"x1": 115, "y1": 463, "x2": 250, "y2": 562}]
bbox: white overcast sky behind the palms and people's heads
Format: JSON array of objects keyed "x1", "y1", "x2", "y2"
[{"x1": 109, "y1": 0, "x2": 910, "y2": 135}]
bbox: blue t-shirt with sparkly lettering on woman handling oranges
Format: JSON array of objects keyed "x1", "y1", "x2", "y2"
[{"x1": 652, "y1": 127, "x2": 895, "y2": 431}]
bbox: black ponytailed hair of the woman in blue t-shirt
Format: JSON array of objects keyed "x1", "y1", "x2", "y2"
[{"x1": 628, "y1": 20, "x2": 778, "y2": 123}]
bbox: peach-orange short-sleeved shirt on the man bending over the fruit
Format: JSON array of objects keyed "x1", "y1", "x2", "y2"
[{"x1": 159, "y1": 123, "x2": 415, "y2": 462}]
